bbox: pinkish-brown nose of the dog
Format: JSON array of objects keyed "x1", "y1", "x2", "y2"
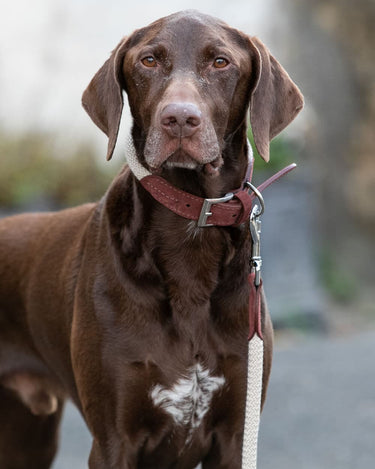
[{"x1": 160, "y1": 103, "x2": 202, "y2": 138}]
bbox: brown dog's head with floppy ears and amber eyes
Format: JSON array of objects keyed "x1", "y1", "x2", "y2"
[{"x1": 82, "y1": 11, "x2": 303, "y2": 175}]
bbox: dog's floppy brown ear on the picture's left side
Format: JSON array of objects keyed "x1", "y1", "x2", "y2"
[{"x1": 82, "y1": 38, "x2": 127, "y2": 160}]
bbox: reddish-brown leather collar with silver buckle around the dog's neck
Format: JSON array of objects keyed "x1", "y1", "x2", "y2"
[{"x1": 140, "y1": 163, "x2": 296, "y2": 227}]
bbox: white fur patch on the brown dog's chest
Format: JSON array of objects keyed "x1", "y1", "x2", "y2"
[{"x1": 151, "y1": 363, "x2": 225, "y2": 435}]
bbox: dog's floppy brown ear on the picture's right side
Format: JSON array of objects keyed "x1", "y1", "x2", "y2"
[{"x1": 250, "y1": 37, "x2": 303, "y2": 161}]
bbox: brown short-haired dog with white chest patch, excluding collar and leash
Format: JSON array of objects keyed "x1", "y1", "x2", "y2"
[{"x1": 0, "y1": 12, "x2": 302, "y2": 469}]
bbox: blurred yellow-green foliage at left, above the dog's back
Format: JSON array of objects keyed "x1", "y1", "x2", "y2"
[{"x1": 0, "y1": 133, "x2": 117, "y2": 209}]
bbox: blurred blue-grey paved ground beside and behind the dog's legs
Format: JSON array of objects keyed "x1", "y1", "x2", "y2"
[{"x1": 54, "y1": 330, "x2": 375, "y2": 469}]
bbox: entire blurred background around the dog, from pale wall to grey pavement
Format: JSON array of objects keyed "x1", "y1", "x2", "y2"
[{"x1": 0, "y1": 0, "x2": 375, "y2": 469}]
